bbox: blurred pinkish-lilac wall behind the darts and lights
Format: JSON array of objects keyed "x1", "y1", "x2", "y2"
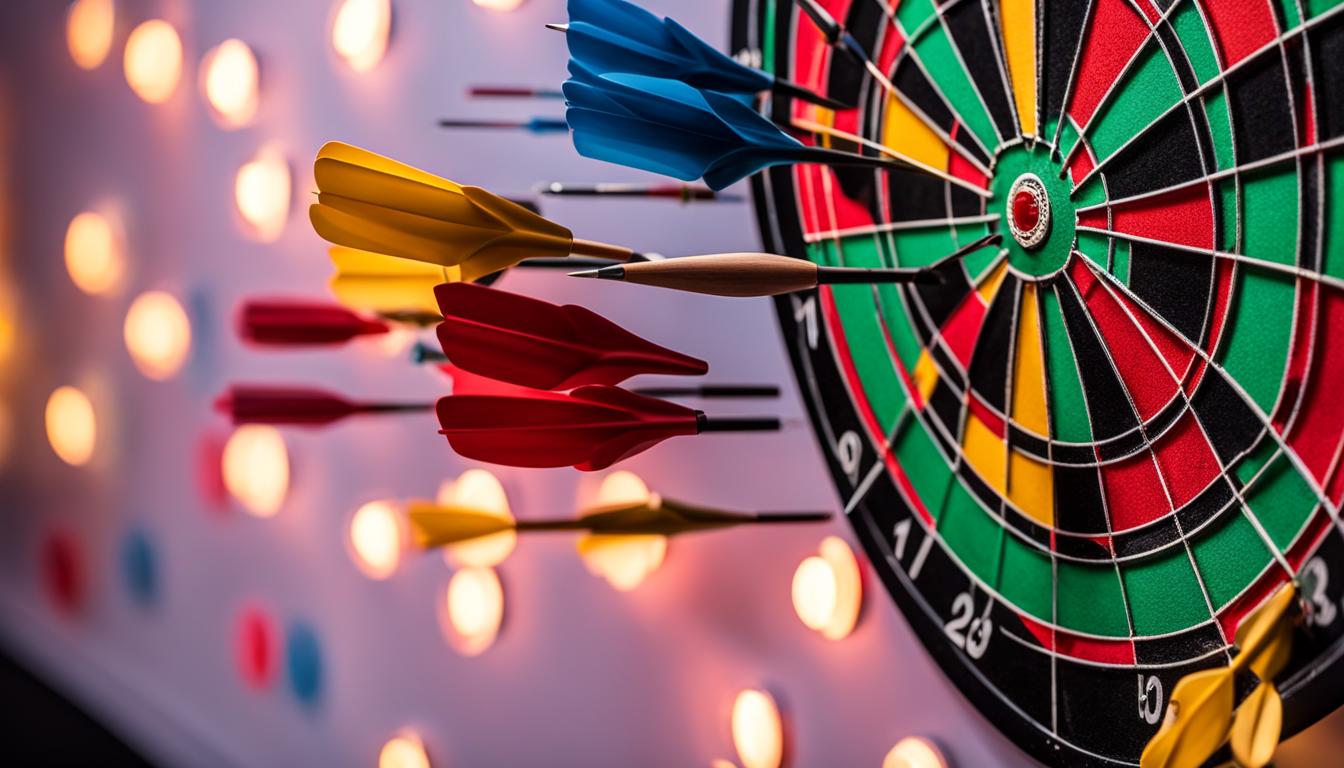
[{"x1": 0, "y1": 0, "x2": 1339, "y2": 767}]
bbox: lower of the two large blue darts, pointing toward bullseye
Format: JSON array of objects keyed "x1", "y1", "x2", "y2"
[{"x1": 563, "y1": 59, "x2": 989, "y2": 196}]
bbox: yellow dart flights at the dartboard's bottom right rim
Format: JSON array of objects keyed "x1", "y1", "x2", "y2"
[{"x1": 1140, "y1": 582, "x2": 1297, "y2": 768}]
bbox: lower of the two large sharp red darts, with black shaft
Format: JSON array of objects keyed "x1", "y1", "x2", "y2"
[{"x1": 437, "y1": 385, "x2": 780, "y2": 471}]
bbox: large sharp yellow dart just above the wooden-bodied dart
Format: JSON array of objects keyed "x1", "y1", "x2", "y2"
[{"x1": 309, "y1": 141, "x2": 634, "y2": 280}]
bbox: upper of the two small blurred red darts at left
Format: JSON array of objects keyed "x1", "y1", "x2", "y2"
[{"x1": 238, "y1": 299, "x2": 388, "y2": 347}]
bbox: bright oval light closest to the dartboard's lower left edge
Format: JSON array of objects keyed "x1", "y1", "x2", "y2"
[{"x1": 793, "y1": 537, "x2": 863, "y2": 640}]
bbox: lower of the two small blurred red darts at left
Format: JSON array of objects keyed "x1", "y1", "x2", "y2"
[{"x1": 215, "y1": 385, "x2": 434, "y2": 426}]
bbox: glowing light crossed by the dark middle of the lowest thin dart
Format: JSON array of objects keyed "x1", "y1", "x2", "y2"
[{"x1": 577, "y1": 471, "x2": 668, "y2": 592}]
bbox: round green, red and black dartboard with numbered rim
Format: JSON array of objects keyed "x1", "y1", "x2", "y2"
[{"x1": 734, "y1": 0, "x2": 1344, "y2": 765}]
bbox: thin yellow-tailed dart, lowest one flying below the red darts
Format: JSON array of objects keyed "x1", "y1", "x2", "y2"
[{"x1": 406, "y1": 494, "x2": 831, "y2": 549}]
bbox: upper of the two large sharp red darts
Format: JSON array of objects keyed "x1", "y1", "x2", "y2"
[{"x1": 434, "y1": 282, "x2": 710, "y2": 390}]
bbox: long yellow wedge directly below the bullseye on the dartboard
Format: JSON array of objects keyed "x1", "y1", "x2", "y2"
[{"x1": 1008, "y1": 282, "x2": 1055, "y2": 526}]
